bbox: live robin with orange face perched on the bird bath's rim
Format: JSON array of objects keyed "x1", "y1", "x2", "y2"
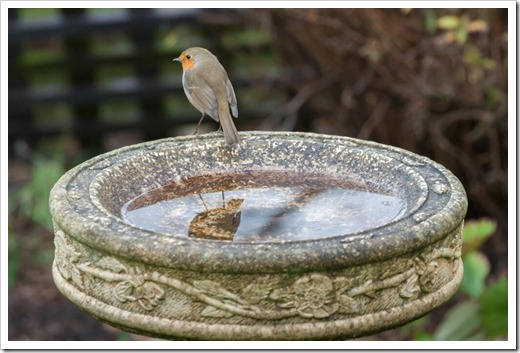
[{"x1": 173, "y1": 48, "x2": 240, "y2": 145}]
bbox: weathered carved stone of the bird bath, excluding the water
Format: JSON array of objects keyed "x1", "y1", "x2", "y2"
[{"x1": 50, "y1": 132, "x2": 467, "y2": 340}]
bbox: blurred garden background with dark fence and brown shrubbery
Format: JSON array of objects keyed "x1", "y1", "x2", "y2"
[{"x1": 8, "y1": 8, "x2": 508, "y2": 340}]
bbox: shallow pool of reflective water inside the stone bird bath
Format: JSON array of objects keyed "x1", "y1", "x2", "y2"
[{"x1": 122, "y1": 172, "x2": 406, "y2": 242}]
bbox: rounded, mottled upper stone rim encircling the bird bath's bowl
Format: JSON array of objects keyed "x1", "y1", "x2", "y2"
[{"x1": 50, "y1": 132, "x2": 467, "y2": 273}]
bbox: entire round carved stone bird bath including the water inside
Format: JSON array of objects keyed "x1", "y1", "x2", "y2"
[{"x1": 50, "y1": 132, "x2": 467, "y2": 340}]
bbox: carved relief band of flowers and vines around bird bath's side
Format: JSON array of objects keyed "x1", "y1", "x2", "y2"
[{"x1": 55, "y1": 230, "x2": 461, "y2": 320}]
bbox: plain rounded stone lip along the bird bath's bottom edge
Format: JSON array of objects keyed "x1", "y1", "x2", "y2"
[{"x1": 52, "y1": 258, "x2": 463, "y2": 340}]
